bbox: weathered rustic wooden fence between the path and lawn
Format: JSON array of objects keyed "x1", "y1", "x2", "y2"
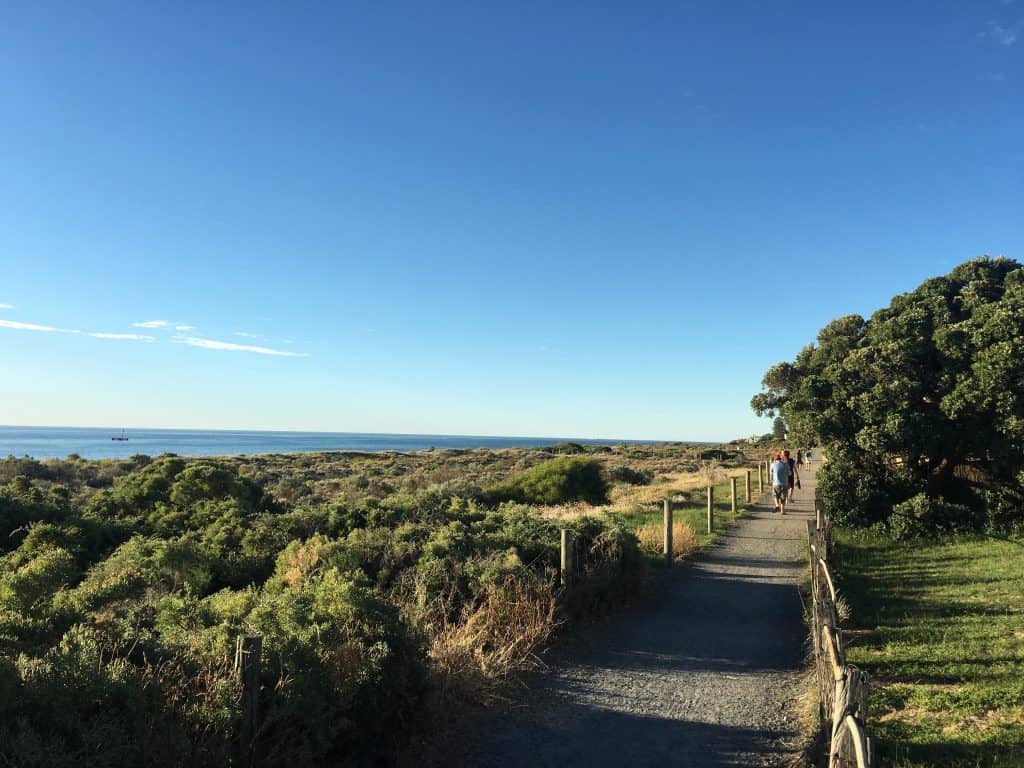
[{"x1": 807, "y1": 500, "x2": 876, "y2": 768}]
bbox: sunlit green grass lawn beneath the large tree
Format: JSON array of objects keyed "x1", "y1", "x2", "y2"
[{"x1": 837, "y1": 530, "x2": 1024, "y2": 768}]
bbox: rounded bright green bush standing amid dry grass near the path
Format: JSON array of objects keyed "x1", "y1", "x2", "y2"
[{"x1": 487, "y1": 457, "x2": 608, "y2": 504}]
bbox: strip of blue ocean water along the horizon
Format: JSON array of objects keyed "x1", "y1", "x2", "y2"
[{"x1": 0, "y1": 426, "x2": 654, "y2": 459}]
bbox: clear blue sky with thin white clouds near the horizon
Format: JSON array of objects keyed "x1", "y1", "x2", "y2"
[{"x1": 0, "y1": 0, "x2": 1024, "y2": 439}]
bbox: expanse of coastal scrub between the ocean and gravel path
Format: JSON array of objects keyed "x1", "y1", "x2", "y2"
[{"x1": 0, "y1": 443, "x2": 761, "y2": 768}]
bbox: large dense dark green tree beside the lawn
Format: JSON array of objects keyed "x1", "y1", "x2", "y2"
[{"x1": 751, "y1": 258, "x2": 1024, "y2": 536}]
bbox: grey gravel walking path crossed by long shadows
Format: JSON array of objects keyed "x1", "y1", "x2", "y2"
[{"x1": 462, "y1": 472, "x2": 814, "y2": 768}]
